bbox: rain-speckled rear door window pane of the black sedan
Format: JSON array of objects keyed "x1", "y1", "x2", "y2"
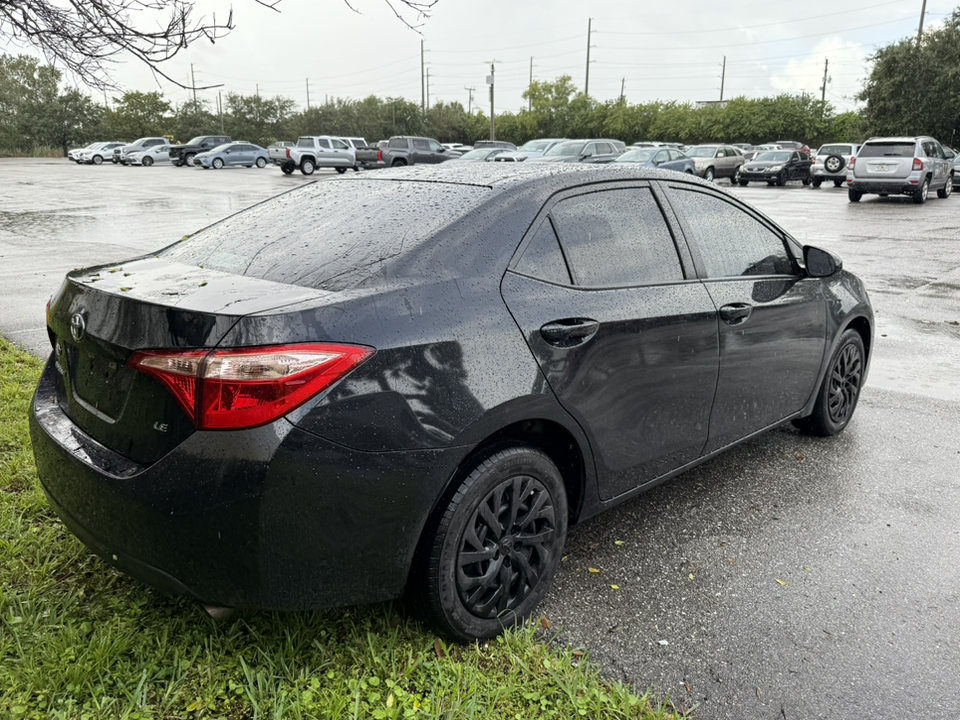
[{"x1": 550, "y1": 188, "x2": 684, "y2": 287}]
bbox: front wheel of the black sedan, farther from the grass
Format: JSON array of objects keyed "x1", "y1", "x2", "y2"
[{"x1": 793, "y1": 330, "x2": 867, "y2": 437}]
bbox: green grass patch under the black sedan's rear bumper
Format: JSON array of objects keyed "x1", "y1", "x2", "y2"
[{"x1": 0, "y1": 338, "x2": 676, "y2": 720}]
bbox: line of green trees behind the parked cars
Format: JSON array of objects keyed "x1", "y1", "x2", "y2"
[{"x1": 0, "y1": 10, "x2": 960, "y2": 155}]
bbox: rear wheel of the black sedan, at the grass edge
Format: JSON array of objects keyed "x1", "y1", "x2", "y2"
[{"x1": 408, "y1": 446, "x2": 567, "y2": 642}]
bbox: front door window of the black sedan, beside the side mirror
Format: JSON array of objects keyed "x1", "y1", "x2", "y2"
[{"x1": 670, "y1": 188, "x2": 794, "y2": 278}]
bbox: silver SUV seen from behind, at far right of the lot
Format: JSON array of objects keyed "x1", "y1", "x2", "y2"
[{"x1": 847, "y1": 137, "x2": 953, "y2": 205}]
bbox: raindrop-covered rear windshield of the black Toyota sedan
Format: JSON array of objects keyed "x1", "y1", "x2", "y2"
[{"x1": 158, "y1": 179, "x2": 490, "y2": 292}]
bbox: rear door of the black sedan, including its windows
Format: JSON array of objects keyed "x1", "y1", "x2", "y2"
[{"x1": 501, "y1": 183, "x2": 719, "y2": 499}]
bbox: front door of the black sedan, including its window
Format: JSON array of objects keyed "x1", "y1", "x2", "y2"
[{"x1": 668, "y1": 184, "x2": 826, "y2": 452}]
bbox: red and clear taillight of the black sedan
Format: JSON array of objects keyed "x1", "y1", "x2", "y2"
[{"x1": 130, "y1": 343, "x2": 374, "y2": 430}]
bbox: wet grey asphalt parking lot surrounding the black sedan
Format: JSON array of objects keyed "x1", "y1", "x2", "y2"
[{"x1": 0, "y1": 160, "x2": 960, "y2": 718}]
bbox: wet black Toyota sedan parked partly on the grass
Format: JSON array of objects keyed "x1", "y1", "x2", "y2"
[{"x1": 30, "y1": 163, "x2": 874, "y2": 640}]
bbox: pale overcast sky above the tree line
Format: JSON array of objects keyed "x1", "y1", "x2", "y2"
[{"x1": 0, "y1": 0, "x2": 957, "y2": 113}]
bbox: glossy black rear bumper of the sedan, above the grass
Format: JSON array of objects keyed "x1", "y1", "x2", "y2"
[{"x1": 30, "y1": 358, "x2": 465, "y2": 610}]
